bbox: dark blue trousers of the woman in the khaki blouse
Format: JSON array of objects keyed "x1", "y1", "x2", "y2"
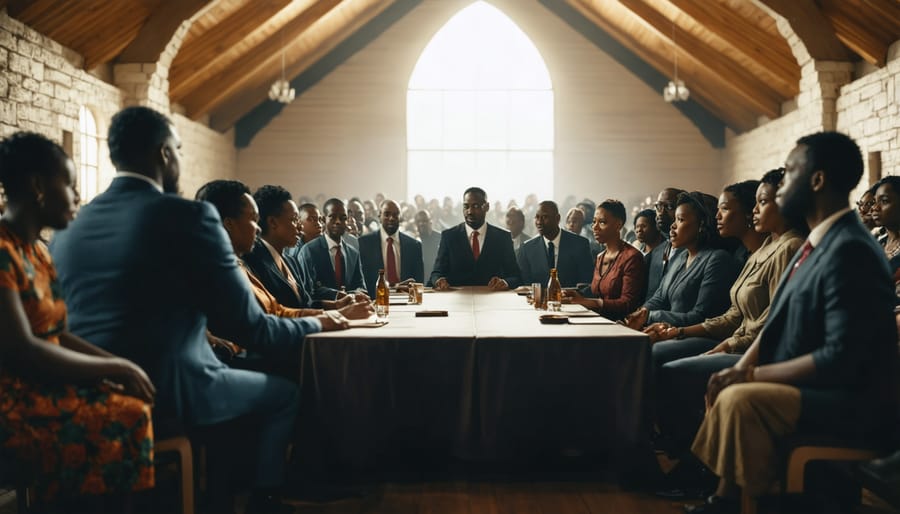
[{"x1": 654, "y1": 348, "x2": 741, "y2": 457}]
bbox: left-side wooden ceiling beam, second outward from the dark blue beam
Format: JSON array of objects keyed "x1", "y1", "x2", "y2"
[{"x1": 180, "y1": 0, "x2": 341, "y2": 119}]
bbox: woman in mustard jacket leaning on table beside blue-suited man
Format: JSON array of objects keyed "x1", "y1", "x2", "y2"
[{"x1": 195, "y1": 180, "x2": 374, "y2": 352}]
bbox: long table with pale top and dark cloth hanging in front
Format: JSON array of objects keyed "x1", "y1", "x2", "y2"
[{"x1": 296, "y1": 287, "x2": 650, "y2": 472}]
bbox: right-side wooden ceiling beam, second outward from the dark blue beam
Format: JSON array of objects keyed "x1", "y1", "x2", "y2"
[{"x1": 619, "y1": 0, "x2": 787, "y2": 118}]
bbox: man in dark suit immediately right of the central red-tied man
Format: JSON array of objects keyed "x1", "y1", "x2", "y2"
[{"x1": 517, "y1": 200, "x2": 594, "y2": 287}]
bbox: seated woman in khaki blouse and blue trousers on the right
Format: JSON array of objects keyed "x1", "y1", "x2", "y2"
[{"x1": 648, "y1": 169, "x2": 807, "y2": 458}]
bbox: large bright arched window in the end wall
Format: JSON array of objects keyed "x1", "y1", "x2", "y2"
[{"x1": 406, "y1": 1, "x2": 553, "y2": 205}]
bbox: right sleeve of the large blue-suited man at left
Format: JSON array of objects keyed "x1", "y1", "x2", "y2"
[{"x1": 182, "y1": 202, "x2": 322, "y2": 353}]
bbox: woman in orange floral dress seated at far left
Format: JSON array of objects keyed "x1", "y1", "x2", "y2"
[{"x1": 0, "y1": 132, "x2": 155, "y2": 502}]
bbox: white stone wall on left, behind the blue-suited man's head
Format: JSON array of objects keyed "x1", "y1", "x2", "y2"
[{"x1": 0, "y1": 9, "x2": 236, "y2": 201}]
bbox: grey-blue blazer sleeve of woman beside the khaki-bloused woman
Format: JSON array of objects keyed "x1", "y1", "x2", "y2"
[{"x1": 647, "y1": 250, "x2": 735, "y2": 327}]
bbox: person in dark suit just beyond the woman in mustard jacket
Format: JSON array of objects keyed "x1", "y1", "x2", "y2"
[{"x1": 243, "y1": 185, "x2": 313, "y2": 309}]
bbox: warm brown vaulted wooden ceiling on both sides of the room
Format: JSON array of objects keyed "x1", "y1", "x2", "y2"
[{"x1": 0, "y1": 0, "x2": 900, "y2": 144}]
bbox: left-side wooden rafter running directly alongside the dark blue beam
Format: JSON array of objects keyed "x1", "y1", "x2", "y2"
[{"x1": 209, "y1": 0, "x2": 394, "y2": 131}]
